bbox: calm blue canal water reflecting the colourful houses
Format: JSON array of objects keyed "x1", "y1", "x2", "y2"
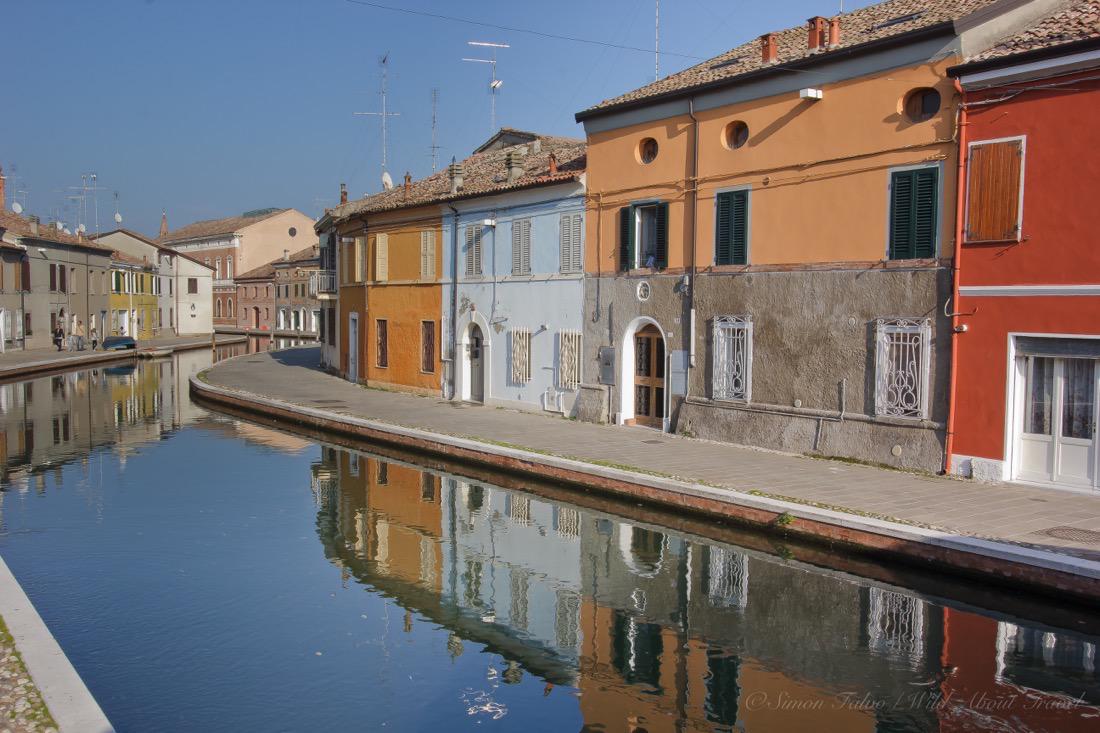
[{"x1": 0, "y1": 347, "x2": 1100, "y2": 733}]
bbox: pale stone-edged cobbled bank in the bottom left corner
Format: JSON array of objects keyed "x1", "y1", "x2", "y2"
[{"x1": 0, "y1": 558, "x2": 114, "y2": 733}]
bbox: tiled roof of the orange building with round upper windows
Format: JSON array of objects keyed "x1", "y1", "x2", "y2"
[{"x1": 576, "y1": 0, "x2": 999, "y2": 121}]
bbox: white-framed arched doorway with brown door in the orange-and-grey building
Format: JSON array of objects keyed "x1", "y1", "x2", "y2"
[{"x1": 619, "y1": 317, "x2": 669, "y2": 430}]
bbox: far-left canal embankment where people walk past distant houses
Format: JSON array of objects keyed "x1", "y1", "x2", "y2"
[{"x1": 0, "y1": 335, "x2": 248, "y2": 381}]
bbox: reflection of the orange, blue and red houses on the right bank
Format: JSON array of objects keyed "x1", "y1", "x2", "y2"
[{"x1": 311, "y1": 447, "x2": 1100, "y2": 733}]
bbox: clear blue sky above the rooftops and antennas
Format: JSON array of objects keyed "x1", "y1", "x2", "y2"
[{"x1": 0, "y1": 0, "x2": 870, "y2": 234}]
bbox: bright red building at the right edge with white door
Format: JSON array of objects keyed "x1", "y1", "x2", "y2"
[{"x1": 947, "y1": 0, "x2": 1100, "y2": 491}]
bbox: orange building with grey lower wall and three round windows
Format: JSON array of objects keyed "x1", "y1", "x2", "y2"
[{"x1": 576, "y1": 0, "x2": 1052, "y2": 470}]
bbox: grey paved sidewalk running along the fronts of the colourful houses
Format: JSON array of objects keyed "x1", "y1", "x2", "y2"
[{"x1": 206, "y1": 348, "x2": 1100, "y2": 560}]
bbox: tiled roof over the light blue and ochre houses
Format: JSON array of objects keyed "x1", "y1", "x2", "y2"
[{"x1": 331, "y1": 133, "x2": 586, "y2": 222}]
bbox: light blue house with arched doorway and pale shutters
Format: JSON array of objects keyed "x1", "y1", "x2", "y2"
[{"x1": 442, "y1": 130, "x2": 584, "y2": 415}]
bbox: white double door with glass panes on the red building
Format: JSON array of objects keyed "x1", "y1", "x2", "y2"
[{"x1": 1016, "y1": 357, "x2": 1100, "y2": 489}]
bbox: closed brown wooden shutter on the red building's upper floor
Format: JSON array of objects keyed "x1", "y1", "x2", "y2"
[{"x1": 965, "y1": 140, "x2": 1024, "y2": 242}]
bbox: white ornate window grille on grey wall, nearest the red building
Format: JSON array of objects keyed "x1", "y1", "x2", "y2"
[{"x1": 875, "y1": 318, "x2": 932, "y2": 419}]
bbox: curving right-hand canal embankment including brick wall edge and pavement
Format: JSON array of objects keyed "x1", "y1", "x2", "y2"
[{"x1": 191, "y1": 348, "x2": 1100, "y2": 603}]
